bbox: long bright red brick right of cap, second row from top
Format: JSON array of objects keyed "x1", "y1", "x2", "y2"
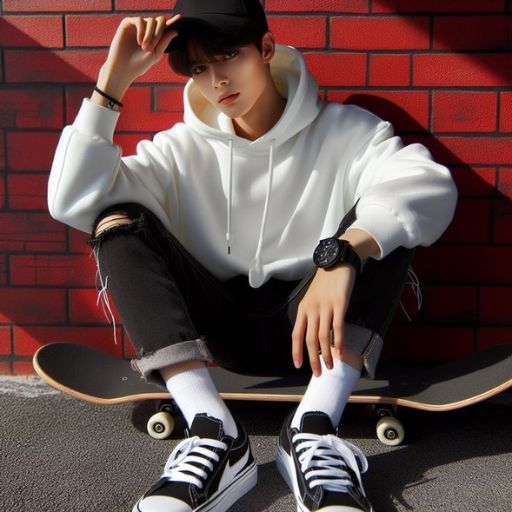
[{"x1": 331, "y1": 17, "x2": 430, "y2": 50}]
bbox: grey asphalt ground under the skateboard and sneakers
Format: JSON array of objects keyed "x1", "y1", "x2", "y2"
[{"x1": 0, "y1": 377, "x2": 512, "y2": 512}]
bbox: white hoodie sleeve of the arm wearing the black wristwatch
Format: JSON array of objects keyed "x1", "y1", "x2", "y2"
[{"x1": 347, "y1": 117, "x2": 457, "y2": 259}]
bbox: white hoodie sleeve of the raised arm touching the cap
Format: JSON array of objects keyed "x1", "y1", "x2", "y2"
[{"x1": 48, "y1": 99, "x2": 174, "y2": 233}]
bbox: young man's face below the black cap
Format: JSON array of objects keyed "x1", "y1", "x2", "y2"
[{"x1": 189, "y1": 34, "x2": 274, "y2": 119}]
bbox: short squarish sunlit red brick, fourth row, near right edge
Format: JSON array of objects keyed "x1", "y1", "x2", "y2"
[{"x1": 432, "y1": 91, "x2": 498, "y2": 133}]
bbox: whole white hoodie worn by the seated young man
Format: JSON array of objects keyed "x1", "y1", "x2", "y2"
[{"x1": 48, "y1": 46, "x2": 456, "y2": 288}]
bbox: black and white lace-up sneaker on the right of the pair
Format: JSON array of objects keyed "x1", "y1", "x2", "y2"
[{"x1": 276, "y1": 412, "x2": 374, "y2": 512}]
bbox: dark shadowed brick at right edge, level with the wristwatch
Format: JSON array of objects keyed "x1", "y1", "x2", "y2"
[{"x1": 414, "y1": 244, "x2": 512, "y2": 285}]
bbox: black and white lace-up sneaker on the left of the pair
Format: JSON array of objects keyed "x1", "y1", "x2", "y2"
[{"x1": 132, "y1": 414, "x2": 257, "y2": 512}]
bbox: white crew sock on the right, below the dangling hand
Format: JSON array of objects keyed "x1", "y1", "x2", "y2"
[{"x1": 291, "y1": 357, "x2": 361, "y2": 428}]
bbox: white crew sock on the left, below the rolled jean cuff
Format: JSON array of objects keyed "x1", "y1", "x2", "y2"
[{"x1": 166, "y1": 367, "x2": 238, "y2": 438}]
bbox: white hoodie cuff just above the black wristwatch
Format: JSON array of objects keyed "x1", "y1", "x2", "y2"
[{"x1": 350, "y1": 205, "x2": 409, "y2": 260}]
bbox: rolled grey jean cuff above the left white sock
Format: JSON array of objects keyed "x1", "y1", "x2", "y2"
[{"x1": 132, "y1": 338, "x2": 213, "y2": 386}]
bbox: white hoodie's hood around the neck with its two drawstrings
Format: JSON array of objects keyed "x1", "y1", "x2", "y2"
[{"x1": 184, "y1": 45, "x2": 320, "y2": 288}]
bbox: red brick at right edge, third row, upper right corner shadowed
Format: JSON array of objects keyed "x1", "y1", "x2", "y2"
[{"x1": 413, "y1": 53, "x2": 512, "y2": 87}]
